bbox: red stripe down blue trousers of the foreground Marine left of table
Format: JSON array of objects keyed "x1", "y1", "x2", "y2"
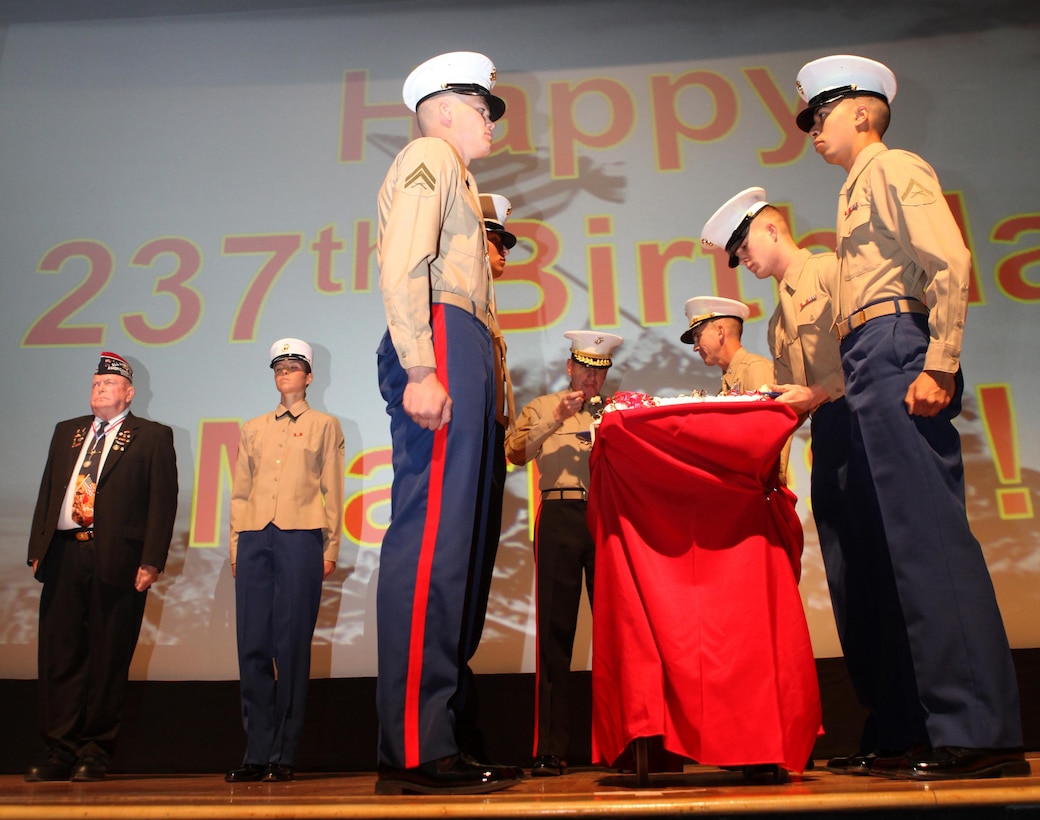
[{"x1": 405, "y1": 305, "x2": 448, "y2": 768}]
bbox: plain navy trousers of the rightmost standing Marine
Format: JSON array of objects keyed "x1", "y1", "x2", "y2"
[{"x1": 841, "y1": 314, "x2": 1022, "y2": 748}]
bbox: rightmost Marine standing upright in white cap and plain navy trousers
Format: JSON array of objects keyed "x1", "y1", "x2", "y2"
[{"x1": 798, "y1": 55, "x2": 1030, "y2": 779}]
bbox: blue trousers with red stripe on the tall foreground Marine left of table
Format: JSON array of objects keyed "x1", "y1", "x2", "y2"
[{"x1": 375, "y1": 304, "x2": 496, "y2": 768}]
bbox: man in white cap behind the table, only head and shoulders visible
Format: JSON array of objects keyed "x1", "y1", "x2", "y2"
[{"x1": 680, "y1": 297, "x2": 775, "y2": 394}]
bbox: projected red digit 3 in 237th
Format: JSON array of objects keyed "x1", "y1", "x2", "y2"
[{"x1": 123, "y1": 236, "x2": 202, "y2": 344}]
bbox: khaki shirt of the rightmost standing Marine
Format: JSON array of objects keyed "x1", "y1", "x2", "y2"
[{"x1": 837, "y1": 143, "x2": 971, "y2": 373}]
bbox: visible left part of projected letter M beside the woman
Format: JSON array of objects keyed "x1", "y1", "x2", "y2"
[{"x1": 188, "y1": 419, "x2": 241, "y2": 546}]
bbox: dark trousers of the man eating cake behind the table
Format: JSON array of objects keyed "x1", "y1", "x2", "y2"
[{"x1": 535, "y1": 498, "x2": 596, "y2": 758}]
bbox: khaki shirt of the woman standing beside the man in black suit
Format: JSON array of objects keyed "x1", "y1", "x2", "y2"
[{"x1": 230, "y1": 400, "x2": 344, "y2": 564}]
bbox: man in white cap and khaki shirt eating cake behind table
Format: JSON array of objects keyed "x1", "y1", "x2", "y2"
[{"x1": 505, "y1": 330, "x2": 622, "y2": 777}]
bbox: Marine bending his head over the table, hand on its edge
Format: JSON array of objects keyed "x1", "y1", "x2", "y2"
[{"x1": 701, "y1": 187, "x2": 898, "y2": 773}]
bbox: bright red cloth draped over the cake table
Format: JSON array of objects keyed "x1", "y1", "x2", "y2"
[{"x1": 589, "y1": 401, "x2": 821, "y2": 771}]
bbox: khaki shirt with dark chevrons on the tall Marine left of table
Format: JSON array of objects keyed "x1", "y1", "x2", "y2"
[{"x1": 376, "y1": 136, "x2": 494, "y2": 369}]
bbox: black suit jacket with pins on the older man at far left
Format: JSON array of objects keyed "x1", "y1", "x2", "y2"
[{"x1": 29, "y1": 413, "x2": 177, "y2": 587}]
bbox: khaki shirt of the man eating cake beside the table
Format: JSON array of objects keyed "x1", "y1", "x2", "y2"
[{"x1": 505, "y1": 388, "x2": 593, "y2": 490}]
